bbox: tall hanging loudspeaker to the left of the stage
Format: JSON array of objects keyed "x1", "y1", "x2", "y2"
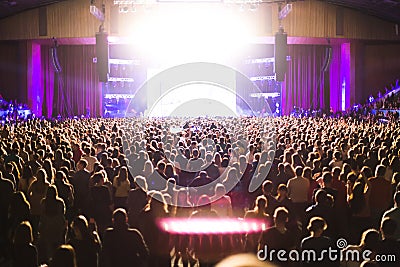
[{"x1": 96, "y1": 32, "x2": 109, "y2": 82}]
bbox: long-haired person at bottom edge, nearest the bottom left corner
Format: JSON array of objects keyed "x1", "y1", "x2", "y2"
[{"x1": 13, "y1": 221, "x2": 38, "y2": 267}]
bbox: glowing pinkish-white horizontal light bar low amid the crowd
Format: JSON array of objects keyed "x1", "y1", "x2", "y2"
[{"x1": 158, "y1": 218, "x2": 269, "y2": 234}]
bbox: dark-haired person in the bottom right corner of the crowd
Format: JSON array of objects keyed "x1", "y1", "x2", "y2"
[{"x1": 378, "y1": 218, "x2": 400, "y2": 267}]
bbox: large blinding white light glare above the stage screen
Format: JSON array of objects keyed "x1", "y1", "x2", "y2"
[{"x1": 125, "y1": 3, "x2": 254, "y2": 64}]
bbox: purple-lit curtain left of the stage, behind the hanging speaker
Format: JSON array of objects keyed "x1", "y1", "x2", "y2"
[{"x1": 42, "y1": 45, "x2": 102, "y2": 117}]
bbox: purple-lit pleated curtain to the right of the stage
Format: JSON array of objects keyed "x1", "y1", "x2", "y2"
[{"x1": 282, "y1": 45, "x2": 327, "y2": 114}]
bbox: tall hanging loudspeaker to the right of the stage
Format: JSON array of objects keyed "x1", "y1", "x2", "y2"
[{"x1": 275, "y1": 31, "x2": 288, "y2": 82}]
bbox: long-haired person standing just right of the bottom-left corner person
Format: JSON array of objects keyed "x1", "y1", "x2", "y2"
[{"x1": 38, "y1": 185, "x2": 66, "y2": 263}]
